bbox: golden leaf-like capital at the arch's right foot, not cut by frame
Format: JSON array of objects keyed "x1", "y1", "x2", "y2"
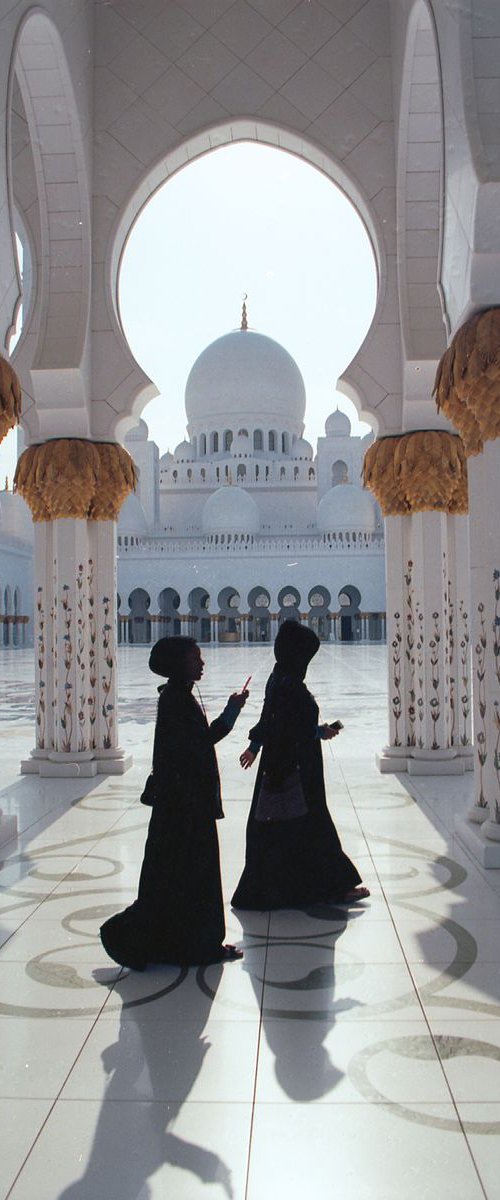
[{"x1": 363, "y1": 430, "x2": 468, "y2": 517}]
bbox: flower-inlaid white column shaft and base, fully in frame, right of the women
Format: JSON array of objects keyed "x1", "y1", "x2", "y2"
[{"x1": 378, "y1": 512, "x2": 471, "y2": 775}]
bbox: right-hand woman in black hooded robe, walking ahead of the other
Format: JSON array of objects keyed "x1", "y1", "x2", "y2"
[{"x1": 233, "y1": 620, "x2": 369, "y2": 908}]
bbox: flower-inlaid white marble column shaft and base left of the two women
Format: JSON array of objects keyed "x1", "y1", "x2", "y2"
[{"x1": 20, "y1": 517, "x2": 132, "y2": 776}]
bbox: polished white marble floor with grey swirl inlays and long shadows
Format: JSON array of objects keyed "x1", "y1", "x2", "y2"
[{"x1": 0, "y1": 646, "x2": 500, "y2": 1200}]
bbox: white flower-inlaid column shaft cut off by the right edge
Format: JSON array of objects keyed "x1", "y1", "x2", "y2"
[{"x1": 459, "y1": 439, "x2": 500, "y2": 868}]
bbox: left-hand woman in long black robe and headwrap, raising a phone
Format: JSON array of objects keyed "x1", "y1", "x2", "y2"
[{"x1": 101, "y1": 637, "x2": 248, "y2": 971}]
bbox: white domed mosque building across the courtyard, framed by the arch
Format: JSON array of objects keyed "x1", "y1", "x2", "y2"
[{"x1": 118, "y1": 304, "x2": 385, "y2": 644}]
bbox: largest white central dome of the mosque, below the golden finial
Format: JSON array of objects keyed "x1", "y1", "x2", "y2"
[{"x1": 186, "y1": 329, "x2": 306, "y2": 425}]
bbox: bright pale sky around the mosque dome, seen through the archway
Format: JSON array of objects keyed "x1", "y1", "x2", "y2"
[{"x1": 0, "y1": 143, "x2": 376, "y2": 481}]
